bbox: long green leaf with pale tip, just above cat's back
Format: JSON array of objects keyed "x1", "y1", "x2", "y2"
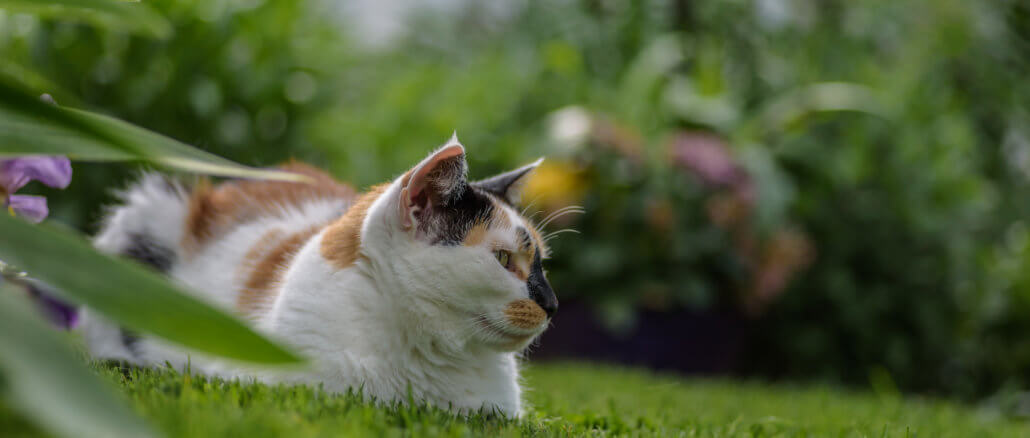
[{"x1": 0, "y1": 75, "x2": 310, "y2": 182}]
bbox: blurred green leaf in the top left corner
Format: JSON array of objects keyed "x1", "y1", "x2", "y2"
[{"x1": 0, "y1": 0, "x2": 172, "y2": 38}]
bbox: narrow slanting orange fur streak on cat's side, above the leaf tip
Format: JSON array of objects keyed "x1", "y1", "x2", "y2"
[{"x1": 236, "y1": 226, "x2": 322, "y2": 314}]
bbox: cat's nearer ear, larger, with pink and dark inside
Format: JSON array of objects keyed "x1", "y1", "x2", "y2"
[{"x1": 400, "y1": 136, "x2": 469, "y2": 229}]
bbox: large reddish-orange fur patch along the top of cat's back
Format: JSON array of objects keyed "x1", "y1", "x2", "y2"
[{"x1": 182, "y1": 162, "x2": 355, "y2": 251}]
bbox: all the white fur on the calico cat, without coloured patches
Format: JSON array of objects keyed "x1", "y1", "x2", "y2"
[{"x1": 80, "y1": 139, "x2": 549, "y2": 416}]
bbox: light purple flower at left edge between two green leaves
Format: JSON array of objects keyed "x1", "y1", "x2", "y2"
[{"x1": 0, "y1": 156, "x2": 71, "y2": 223}]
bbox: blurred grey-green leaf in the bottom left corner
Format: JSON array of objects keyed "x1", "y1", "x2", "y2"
[{"x1": 0, "y1": 284, "x2": 152, "y2": 438}]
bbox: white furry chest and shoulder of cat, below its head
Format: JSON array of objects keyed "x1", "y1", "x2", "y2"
[{"x1": 264, "y1": 236, "x2": 519, "y2": 414}]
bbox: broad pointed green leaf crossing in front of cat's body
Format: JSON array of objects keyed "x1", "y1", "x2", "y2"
[{"x1": 0, "y1": 214, "x2": 300, "y2": 364}]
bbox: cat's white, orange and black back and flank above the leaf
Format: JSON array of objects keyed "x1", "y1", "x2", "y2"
[{"x1": 96, "y1": 162, "x2": 356, "y2": 315}]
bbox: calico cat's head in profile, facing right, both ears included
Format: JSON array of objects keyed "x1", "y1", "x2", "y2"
[{"x1": 323, "y1": 137, "x2": 558, "y2": 351}]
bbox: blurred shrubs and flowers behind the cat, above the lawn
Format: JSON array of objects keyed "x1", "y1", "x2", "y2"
[{"x1": 6, "y1": 0, "x2": 1030, "y2": 415}]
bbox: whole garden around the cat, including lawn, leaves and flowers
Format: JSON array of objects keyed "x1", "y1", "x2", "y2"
[{"x1": 0, "y1": 0, "x2": 1030, "y2": 437}]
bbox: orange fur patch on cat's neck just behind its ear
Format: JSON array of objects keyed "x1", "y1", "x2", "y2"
[{"x1": 321, "y1": 182, "x2": 389, "y2": 269}]
